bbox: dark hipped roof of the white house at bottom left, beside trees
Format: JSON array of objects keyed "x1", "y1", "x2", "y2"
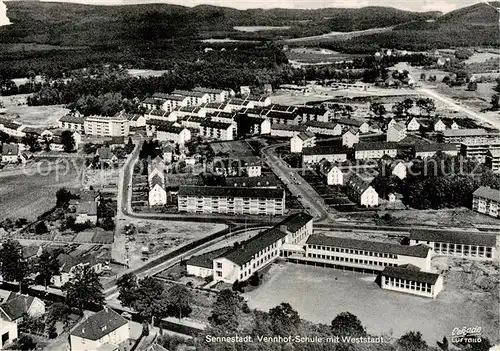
[{"x1": 71, "y1": 307, "x2": 128, "y2": 340}]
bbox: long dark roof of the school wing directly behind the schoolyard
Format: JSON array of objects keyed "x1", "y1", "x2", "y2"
[{"x1": 307, "y1": 234, "x2": 430, "y2": 258}]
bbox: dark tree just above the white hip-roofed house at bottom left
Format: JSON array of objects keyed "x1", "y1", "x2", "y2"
[{"x1": 62, "y1": 266, "x2": 104, "y2": 310}]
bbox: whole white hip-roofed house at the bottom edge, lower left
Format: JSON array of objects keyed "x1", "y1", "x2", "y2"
[{"x1": 69, "y1": 307, "x2": 130, "y2": 351}]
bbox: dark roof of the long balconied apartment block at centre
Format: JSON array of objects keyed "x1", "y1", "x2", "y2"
[{"x1": 178, "y1": 185, "x2": 285, "y2": 199}]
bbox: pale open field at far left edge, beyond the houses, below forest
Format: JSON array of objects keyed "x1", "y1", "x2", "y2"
[{"x1": 2, "y1": 101, "x2": 70, "y2": 127}]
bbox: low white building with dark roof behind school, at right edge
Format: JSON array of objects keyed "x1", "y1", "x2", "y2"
[{"x1": 410, "y1": 229, "x2": 498, "y2": 261}]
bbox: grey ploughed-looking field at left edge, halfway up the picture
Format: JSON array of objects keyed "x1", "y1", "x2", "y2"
[{"x1": 0, "y1": 167, "x2": 81, "y2": 220}]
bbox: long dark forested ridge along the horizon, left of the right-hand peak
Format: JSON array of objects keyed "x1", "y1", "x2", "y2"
[{"x1": 0, "y1": 1, "x2": 437, "y2": 46}]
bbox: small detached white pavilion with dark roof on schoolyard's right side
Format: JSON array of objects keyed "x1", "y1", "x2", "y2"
[{"x1": 380, "y1": 264, "x2": 443, "y2": 299}]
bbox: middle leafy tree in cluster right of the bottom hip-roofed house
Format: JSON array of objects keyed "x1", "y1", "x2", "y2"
[{"x1": 133, "y1": 277, "x2": 168, "y2": 325}]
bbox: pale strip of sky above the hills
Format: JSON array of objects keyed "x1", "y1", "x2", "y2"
[{"x1": 29, "y1": 0, "x2": 481, "y2": 12}]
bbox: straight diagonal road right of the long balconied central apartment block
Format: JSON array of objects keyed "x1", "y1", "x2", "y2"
[{"x1": 261, "y1": 142, "x2": 332, "y2": 223}]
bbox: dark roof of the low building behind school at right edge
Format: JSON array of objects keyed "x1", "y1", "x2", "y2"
[{"x1": 410, "y1": 229, "x2": 497, "y2": 247}]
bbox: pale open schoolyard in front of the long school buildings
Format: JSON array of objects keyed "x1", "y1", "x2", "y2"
[{"x1": 245, "y1": 263, "x2": 498, "y2": 345}]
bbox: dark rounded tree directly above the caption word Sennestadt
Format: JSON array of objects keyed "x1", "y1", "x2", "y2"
[{"x1": 209, "y1": 289, "x2": 243, "y2": 331}]
